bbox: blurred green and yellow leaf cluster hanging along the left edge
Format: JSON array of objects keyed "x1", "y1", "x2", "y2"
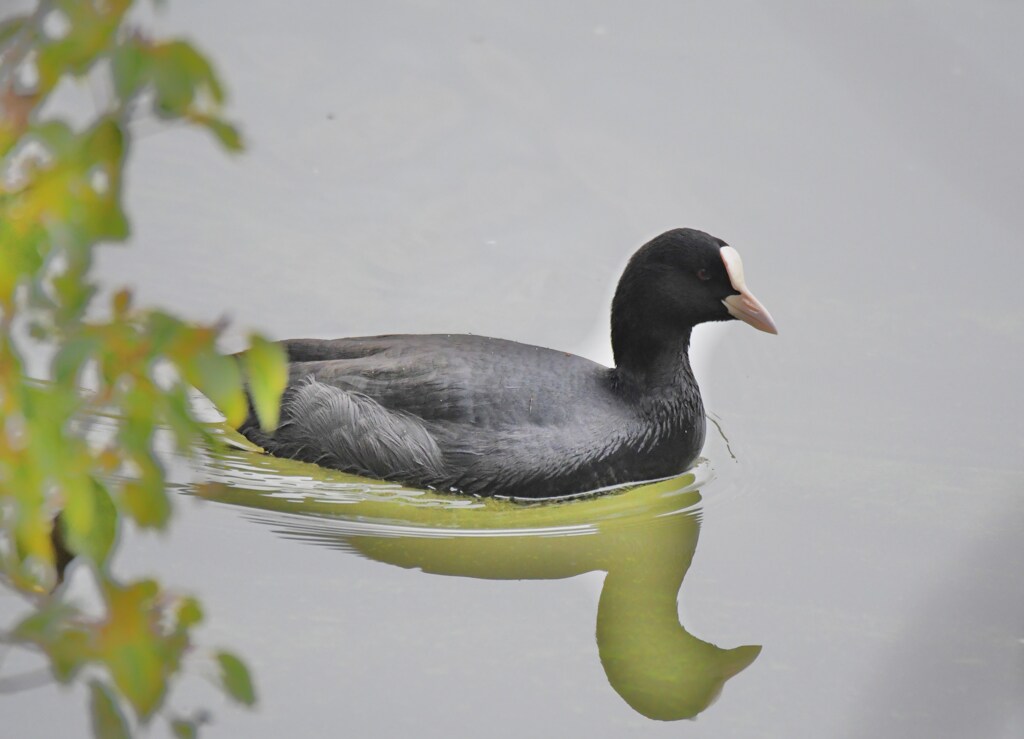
[{"x1": 0, "y1": 0, "x2": 287, "y2": 737}]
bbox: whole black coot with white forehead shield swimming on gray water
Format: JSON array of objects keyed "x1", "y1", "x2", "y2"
[{"x1": 240, "y1": 228, "x2": 776, "y2": 497}]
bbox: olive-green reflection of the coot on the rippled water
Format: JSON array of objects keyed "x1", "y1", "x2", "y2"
[{"x1": 194, "y1": 431, "x2": 761, "y2": 721}]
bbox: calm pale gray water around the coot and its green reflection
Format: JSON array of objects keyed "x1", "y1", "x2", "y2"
[{"x1": 0, "y1": 0, "x2": 1024, "y2": 738}]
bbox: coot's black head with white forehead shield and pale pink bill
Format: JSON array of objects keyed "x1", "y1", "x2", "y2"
[{"x1": 611, "y1": 228, "x2": 777, "y2": 363}]
